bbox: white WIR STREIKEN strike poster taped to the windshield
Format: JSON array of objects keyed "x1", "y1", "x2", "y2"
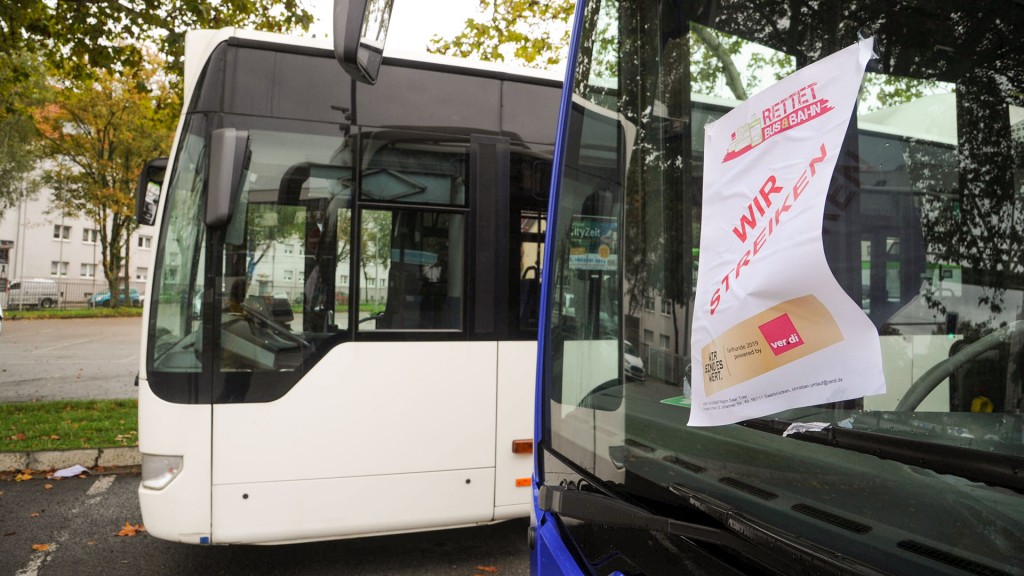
[{"x1": 689, "y1": 34, "x2": 885, "y2": 426}]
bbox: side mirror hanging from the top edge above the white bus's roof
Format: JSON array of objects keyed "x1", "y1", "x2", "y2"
[{"x1": 334, "y1": 0, "x2": 394, "y2": 84}]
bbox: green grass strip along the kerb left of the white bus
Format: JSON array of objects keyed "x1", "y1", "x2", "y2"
[{"x1": 0, "y1": 400, "x2": 138, "y2": 452}]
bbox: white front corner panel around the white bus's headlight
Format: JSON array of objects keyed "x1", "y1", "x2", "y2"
[{"x1": 138, "y1": 380, "x2": 212, "y2": 544}]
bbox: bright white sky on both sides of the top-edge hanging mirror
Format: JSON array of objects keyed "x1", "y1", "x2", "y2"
[{"x1": 307, "y1": 0, "x2": 480, "y2": 53}]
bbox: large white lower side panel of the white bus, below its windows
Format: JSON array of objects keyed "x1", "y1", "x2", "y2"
[{"x1": 206, "y1": 341, "x2": 537, "y2": 543}]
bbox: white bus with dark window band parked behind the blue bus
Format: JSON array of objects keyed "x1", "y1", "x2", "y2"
[{"x1": 138, "y1": 12, "x2": 561, "y2": 544}]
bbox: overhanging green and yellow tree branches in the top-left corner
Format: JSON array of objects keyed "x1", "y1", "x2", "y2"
[{"x1": 0, "y1": 0, "x2": 313, "y2": 209}]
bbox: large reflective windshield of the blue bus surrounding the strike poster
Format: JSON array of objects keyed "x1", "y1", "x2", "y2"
[{"x1": 543, "y1": 0, "x2": 1024, "y2": 573}]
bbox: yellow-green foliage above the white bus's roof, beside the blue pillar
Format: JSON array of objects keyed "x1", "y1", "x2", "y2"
[{"x1": 428, "y1": 0, "x2": 575, "y2": 68}]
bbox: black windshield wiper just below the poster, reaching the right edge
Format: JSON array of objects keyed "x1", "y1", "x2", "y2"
[{"x1": 740, "y1": 418, "x2": 1024, "y2": 492}]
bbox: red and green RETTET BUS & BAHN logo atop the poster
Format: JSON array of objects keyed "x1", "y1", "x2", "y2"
[{"x1": 722, "y1": 82, "x2": 835, "y2": 164}]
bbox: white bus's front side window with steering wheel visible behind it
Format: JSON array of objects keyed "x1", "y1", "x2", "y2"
[{"x1": 219, "y1": 130, "x2": 352, "y2": 371}]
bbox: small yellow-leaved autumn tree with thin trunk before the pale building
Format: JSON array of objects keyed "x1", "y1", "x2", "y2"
[{"x1": 35, "y1": 54, "x2": 180, "y2": 305}]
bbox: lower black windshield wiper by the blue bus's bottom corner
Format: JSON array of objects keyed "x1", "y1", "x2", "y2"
[{"x1": 538, "y1": 484, "x2": 884, "y2": 576}]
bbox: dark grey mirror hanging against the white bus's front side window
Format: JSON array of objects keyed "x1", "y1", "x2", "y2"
[{"x1": 206, "y1": 128, "x2": 251, "y2": 228}]
